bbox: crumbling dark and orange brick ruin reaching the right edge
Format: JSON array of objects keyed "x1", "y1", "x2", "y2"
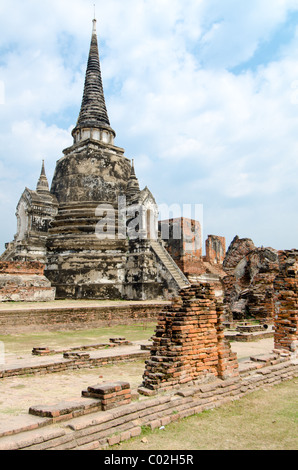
[{"x1": 222, "y1": 236, "x2": 298, "y2": 353}]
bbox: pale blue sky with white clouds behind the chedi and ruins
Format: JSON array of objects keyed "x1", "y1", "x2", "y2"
[{"x1": 0, "y1": 0, "x2": 298, "y2": 251}]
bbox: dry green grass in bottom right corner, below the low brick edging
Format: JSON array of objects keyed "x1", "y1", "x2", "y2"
[{"x1": 114, "y1": 379, "x2": 298, "y2": 450}]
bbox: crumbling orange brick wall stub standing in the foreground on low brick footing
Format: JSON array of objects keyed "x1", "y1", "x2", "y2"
[{"x1": 139, "y1": 284, "x2": 238, "y2": 394}]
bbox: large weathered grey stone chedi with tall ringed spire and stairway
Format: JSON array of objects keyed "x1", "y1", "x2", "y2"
[{"x1": 1, "y1": 19, "x2": 189, "y2": 299}]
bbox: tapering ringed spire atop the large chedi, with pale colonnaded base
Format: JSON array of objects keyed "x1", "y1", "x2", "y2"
[{"x1": 72, "y1": 19, "x2": 116, "y2": 144}]
